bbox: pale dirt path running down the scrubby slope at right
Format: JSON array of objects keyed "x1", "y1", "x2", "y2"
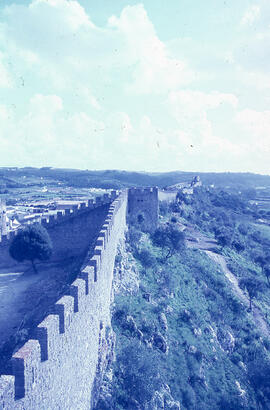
[{"x1": 182, "y1": 225, "x2": 270, "y2": 338}]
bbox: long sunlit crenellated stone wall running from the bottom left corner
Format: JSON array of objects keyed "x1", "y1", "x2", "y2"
[{"x1": 0, "y1": 193, "x2": 127, "y2": 410}]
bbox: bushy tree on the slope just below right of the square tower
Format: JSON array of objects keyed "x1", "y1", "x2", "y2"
[{"x1": 152, "y1": 224, "x2": 185, "y2": 261}]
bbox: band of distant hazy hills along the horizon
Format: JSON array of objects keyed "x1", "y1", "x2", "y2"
[{"x1": 0, "y1": 167, "x2": 270, "y2": 189}]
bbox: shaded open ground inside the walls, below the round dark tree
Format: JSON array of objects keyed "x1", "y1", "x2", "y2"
[{"x1": 0, "y1": 258, "x2": 83, "y2": 371}]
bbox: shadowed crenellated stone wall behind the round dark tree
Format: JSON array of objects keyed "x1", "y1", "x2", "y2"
[{"x1": 0, "y1": 195, "x2": 115, "y2": 268}]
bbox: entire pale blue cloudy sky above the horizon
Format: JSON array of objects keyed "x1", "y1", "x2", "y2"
[{"x1": 0, "y1": 0, "x2": 270, "y2": 174}]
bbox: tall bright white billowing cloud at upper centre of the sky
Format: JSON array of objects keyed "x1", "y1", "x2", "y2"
[{"x1": 109, "y1": 5, "x2": 194, "y2": 94}]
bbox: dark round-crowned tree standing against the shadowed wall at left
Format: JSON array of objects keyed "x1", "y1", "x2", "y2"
[{"x1": 9, "y1": 224, "x2": 52, "y2": 273}]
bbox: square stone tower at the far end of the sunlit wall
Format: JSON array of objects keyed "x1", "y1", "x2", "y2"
[{"x1": 127, "y1": 187, "x2": 158, "y2": 232}]
